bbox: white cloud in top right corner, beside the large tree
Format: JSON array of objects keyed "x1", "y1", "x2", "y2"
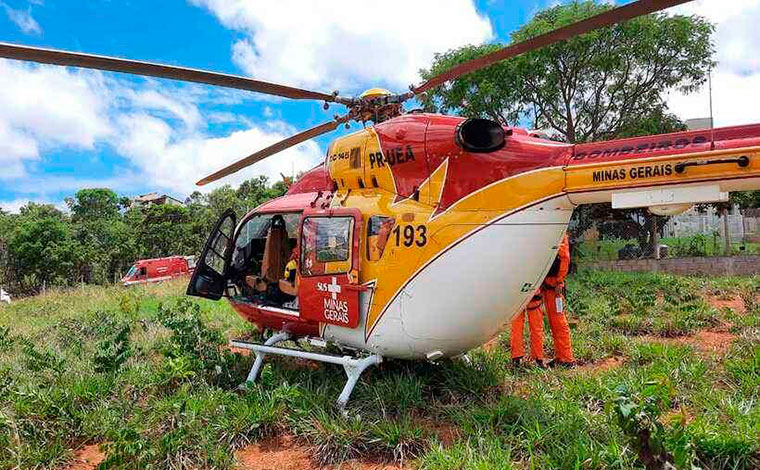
[{"x1": 668, "y1": 0, "x2": 760, "y2": 126}]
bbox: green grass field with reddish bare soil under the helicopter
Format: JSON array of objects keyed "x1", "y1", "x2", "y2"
[{"x1": 0, "y1": 273, "x2": 760, "y2": 470}]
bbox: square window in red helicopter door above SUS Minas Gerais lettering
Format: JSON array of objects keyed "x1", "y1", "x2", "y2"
[{"x1": 301, "y1": 217, "x2": 354, "y2": 276}]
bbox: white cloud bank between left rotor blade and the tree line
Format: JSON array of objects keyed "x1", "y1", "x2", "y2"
[{"x1": 0, "y1": 60, "x2": 322, "y2": 199}]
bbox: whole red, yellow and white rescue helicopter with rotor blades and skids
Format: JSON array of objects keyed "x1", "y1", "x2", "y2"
[{"x1": 0, "y1": 0, "x2": 760, "y2": 406}]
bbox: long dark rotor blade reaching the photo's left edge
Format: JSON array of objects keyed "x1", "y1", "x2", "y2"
[{"x1": 0, "y1": 42, "x2": 339, "y2": 102}]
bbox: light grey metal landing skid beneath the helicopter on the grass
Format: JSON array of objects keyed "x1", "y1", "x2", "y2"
[{"x1": 230, "y1": 332, "x2": 383, "y2": 409}]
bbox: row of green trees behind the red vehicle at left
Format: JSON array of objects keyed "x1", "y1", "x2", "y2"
[{"x1": 0, "y1": 176, "x2": 287, "y2": 295}]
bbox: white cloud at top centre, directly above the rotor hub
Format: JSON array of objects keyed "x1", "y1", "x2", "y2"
[{"x1": 190, "y1": 0, "x2": 493, "y2": 94}]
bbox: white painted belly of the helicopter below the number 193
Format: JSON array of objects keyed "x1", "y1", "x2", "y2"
[{"x1": 325, "y1": 198, "x2": 572, "y2": 358}]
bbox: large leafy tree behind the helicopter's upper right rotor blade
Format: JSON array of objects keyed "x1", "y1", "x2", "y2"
[{"x1": 421, "y1": 1, "x2": 714, "y2": 143}]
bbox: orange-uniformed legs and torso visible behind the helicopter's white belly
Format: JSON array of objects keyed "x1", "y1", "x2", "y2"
[{"x1": 510, "y1": 234, "x2": 575, "y2": 367}]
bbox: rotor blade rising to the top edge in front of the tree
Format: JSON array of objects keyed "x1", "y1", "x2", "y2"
[{"x1": 412, "y1": 0, "x2": 692, "y2": 95}]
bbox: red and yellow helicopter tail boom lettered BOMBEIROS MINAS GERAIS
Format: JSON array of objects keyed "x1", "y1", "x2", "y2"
[{"x1": 565, "y1": 124, "x2": 760, "y2": 208}]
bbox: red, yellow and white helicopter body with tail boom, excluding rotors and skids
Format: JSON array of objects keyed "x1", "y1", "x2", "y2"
[{"x1": 223, "y1": 114, "x2": 760, "y2": 359}]
